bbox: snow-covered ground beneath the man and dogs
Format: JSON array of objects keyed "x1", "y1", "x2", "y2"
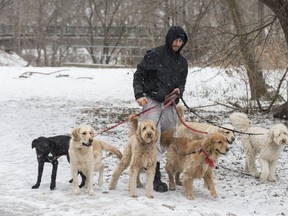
[{"x1": 0, "y1": 59, "x2": 288, "y2": 216}]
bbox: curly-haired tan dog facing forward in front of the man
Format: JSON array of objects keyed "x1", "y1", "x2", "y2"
[{"x1": 109, "y1": 115, "x2": 158, "y2": 198}]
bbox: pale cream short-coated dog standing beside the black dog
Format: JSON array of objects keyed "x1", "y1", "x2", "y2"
[{"x1": 68, "y1": 125, "x2": 122, "y2": 196}]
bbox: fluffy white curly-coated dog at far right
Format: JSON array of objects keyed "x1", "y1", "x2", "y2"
[{"x1": 230, "y1": 113, "x2": 288, "y2": 182}]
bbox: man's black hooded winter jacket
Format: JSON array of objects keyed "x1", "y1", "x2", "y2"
[{"x1": 133, "y1": 26, "x2": 188, "y2": 102}]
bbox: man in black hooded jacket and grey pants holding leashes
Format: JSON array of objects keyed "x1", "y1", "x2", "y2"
[{"x1": 133, "y1": 26, "x2": 188, "y2": 192}]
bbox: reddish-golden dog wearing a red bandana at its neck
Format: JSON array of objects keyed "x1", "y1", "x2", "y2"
[{"x1": 165, "y1": 132, "x2": 229, "y2": 200}]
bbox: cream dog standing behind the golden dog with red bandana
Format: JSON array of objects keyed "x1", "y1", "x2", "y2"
[{"x1": 177, "y1": 105, "x2": 235, "y2": 144}]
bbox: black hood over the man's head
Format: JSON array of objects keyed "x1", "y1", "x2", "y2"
[{"x1": 166, "y1": 26, "x2": 188, "y2": 53}]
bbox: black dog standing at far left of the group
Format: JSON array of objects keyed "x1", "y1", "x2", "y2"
[{"x1": 32, "y1": 135, "x2": 86, "y2": 190}]
